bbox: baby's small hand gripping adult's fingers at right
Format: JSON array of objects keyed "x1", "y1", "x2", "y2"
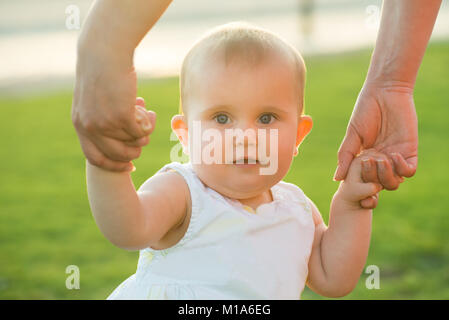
[{"x1": 338, "y1": 149, "x2": 389, "y2": 208}]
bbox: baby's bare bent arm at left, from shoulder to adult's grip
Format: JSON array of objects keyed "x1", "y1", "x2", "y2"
[{"x1": 86, "y1": 105, "x2": 190, "y2": 250}]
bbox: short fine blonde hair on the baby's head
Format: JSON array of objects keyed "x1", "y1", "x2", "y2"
[{"x1": 179, "y1": 22, "x2": 306, "y2": 114}]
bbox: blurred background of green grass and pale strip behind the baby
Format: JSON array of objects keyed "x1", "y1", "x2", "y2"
[{"x1": 0, "y1": 0, "x2": 449, "y2": 299}]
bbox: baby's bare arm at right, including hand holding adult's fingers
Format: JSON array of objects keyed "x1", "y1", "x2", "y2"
[{"x1": 307, "y1": 151, "x2": 388, "y2": 297}]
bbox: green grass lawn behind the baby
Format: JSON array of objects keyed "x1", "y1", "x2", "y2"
[{"x1": 0, "y1": 43, "x2": 449, "y2": 299}]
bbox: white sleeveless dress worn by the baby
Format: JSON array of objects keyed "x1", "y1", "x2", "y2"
[{"x1": 108, "y1": 162, "x2": 315, "y2": 300}]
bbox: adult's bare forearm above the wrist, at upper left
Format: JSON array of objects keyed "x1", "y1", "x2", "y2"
[{"x1": 78, "y1": 0, "x2": 172, "y2": 68}]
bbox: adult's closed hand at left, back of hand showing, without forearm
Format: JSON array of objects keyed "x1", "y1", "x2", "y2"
[{"x1": 72, "y1": 63, "x2": 154, "y2": 171}]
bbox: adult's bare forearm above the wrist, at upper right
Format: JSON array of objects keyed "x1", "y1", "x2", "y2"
[{"x1": 367, "y1": 0, "x2": 441, "y2": 88}]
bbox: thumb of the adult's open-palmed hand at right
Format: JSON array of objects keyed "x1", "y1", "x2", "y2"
[{"x1": 334, "y1": 125, "x2": 361, "y2": 181}]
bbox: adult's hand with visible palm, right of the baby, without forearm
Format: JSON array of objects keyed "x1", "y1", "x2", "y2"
[{"x1": 334, "y1": 83, "x2": 418, "y2": 208}]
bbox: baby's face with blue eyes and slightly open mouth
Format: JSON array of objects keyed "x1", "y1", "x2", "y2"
[{"x1": 177, "y1": 52, "x2": 301, "y2": 199}]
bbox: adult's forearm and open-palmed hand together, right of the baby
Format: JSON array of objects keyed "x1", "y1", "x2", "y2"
[{"x1": 334, "y1": 0, "x2": 441, "y2": 208}]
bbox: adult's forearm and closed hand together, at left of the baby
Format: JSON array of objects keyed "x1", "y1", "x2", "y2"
[{"x1": 72, "y1": 0, "x2": 171, "y2": 171}]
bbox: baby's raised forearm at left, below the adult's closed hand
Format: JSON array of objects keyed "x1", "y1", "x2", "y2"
[{"x1": 86, "y1": 161, "x2": 144, "y2": 249}]
